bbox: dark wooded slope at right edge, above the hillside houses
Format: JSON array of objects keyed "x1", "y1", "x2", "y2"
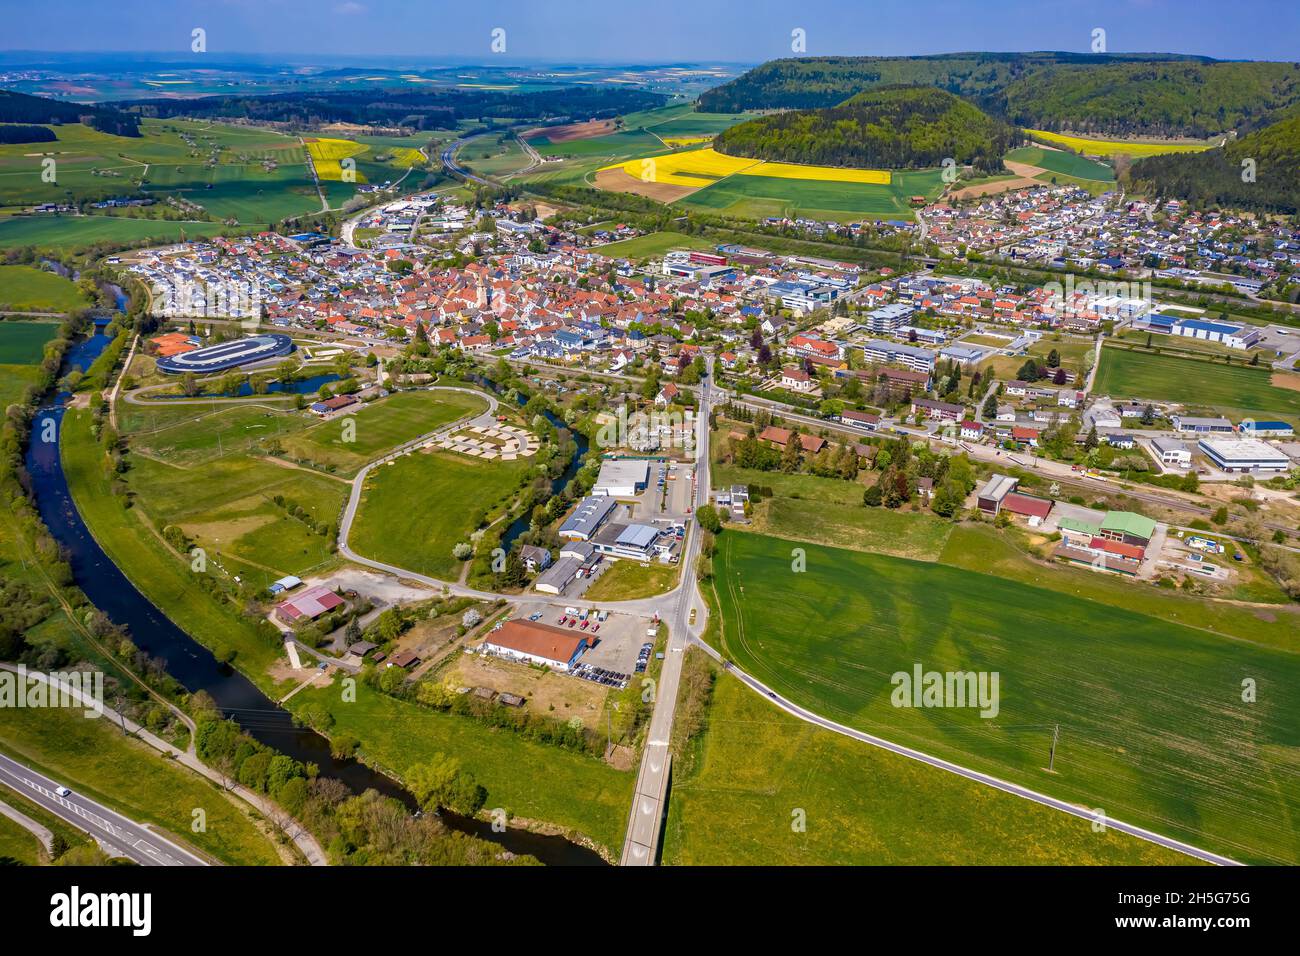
[{"x1": 1127, "y1": 108, "x2": 1300, "y2": 213}]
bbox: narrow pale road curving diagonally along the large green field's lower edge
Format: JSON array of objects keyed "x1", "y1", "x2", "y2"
[{"x1": 694, "y1": 639, "x2": 1242, "y2": 866}]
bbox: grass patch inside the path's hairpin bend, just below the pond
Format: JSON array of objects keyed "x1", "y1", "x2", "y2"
[{"x1": 281, "y1": 392, "x2": 488, "y2": 475}]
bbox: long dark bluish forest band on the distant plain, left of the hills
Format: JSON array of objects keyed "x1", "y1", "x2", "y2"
[{"x1": 124, "y1": 86, "x2": 667, "y2": 130}]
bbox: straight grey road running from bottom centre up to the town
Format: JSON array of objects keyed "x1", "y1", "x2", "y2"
[{"x1": 620, "y1": 356, "x2": 712, "y2": 866}]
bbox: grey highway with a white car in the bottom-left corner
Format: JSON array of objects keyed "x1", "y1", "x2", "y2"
[{"x1": 0, "y1": 756, "x2": 208, "y2": 866}]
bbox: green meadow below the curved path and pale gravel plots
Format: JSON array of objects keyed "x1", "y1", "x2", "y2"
[{"x1": 348, "y1": 451, "x2": 532, "y2": 580}]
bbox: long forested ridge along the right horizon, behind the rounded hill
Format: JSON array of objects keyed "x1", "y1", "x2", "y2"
[{"x1": 699, "y1": 53, "x2": 1300, "y2": 138}]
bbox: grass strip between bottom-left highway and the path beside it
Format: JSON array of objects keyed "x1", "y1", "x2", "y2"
[{"x1": 0, "y1": 708, "x2": 280, "y2": 866}]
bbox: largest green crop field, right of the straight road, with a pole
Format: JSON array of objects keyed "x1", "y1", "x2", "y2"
[{"x1": 715, "y1": 533, "x2": 1300, "y2": 864}]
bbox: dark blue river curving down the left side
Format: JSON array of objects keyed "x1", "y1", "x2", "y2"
[{"x1": 26, "y1": 332, "x2": 605, "y2": 866}]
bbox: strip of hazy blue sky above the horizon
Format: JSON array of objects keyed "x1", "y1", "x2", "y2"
[{"x1": 0, "y1": 0, "x2": 1300, "y2": 62}]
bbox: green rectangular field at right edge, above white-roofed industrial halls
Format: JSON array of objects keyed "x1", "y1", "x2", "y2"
[{"x1": 1095, "y1": 349, "x2": 1300, "y2": 421}]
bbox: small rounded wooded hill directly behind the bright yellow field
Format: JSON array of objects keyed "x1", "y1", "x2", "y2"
[{"x1": 714, "y1": 86, "x2": 1021, "y2": 172}]
